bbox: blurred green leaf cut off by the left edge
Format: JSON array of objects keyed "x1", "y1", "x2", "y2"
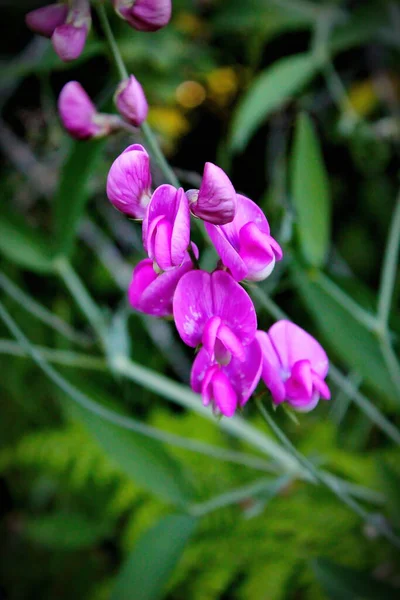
[{"x1": 0, "y1": 214, "x2": 53, "y2": 273}]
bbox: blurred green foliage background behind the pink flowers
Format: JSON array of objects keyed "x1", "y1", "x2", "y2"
[{"x1": 0, "y1": 0, "x2": 400, "y2": 600}]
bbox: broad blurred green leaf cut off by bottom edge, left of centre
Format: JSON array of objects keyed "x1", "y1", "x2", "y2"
[{"x1": 111, "y1": 515, "x2": 197, "y2": 600}]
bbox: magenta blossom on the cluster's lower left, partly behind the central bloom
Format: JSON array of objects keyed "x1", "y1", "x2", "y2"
[{"x1": 128, "y1": 249, "x2": 197, "y2": 317}]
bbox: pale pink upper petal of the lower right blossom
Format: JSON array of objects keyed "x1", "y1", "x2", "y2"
[{"x1": 268, "y1": 320, "x2": 329, "y2": 379}]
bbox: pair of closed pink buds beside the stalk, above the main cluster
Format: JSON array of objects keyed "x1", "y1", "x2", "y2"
[{"x1": 58, "y1": 75, "x2": 148, "y2": 140}]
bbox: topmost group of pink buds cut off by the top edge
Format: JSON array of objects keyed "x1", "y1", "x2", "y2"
[{"x1": 25, "y1": 0, "x2": 171, "y2": 62}]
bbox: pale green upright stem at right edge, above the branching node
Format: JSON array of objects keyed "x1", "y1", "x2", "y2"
[{"x1": 378, "y1": 192, "x2": 400, "y2": 330}]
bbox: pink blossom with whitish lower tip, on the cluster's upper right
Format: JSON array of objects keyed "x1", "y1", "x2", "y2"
[{"x1": 205, "y1": 194, "x2": 282, "y2": 281}]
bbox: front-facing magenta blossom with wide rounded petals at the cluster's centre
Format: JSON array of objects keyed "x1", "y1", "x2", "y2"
[{"x1": 173, "y1": 270, "x2": 257, "y2": 365}]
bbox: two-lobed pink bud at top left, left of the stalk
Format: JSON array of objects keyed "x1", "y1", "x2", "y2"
[{"x1": 25, "y1": 0, "x2": 92, "y2": 62}]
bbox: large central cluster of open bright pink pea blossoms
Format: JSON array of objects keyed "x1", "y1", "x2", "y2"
[{"x1": 107, "y1": 149, "x2": 330, "y2": 417}]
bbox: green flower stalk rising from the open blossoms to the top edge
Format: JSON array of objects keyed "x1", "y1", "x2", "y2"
[{"x1": 97, "y1": 4, "x2": 180, "y2": 187}]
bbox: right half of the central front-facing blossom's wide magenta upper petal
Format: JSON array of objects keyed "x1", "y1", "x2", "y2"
[{"x1": 211, "y1": 271, "x2": 257, "y2": 345}]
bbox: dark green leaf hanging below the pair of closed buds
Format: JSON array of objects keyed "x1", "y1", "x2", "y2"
[{"x1": 54, "y1": 139, "x2": 105, "y2": 256}]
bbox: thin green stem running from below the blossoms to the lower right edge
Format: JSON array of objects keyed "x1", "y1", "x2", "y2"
[{"x1": 256, "y1": 399, "x2": 400, "y2": 548}]
